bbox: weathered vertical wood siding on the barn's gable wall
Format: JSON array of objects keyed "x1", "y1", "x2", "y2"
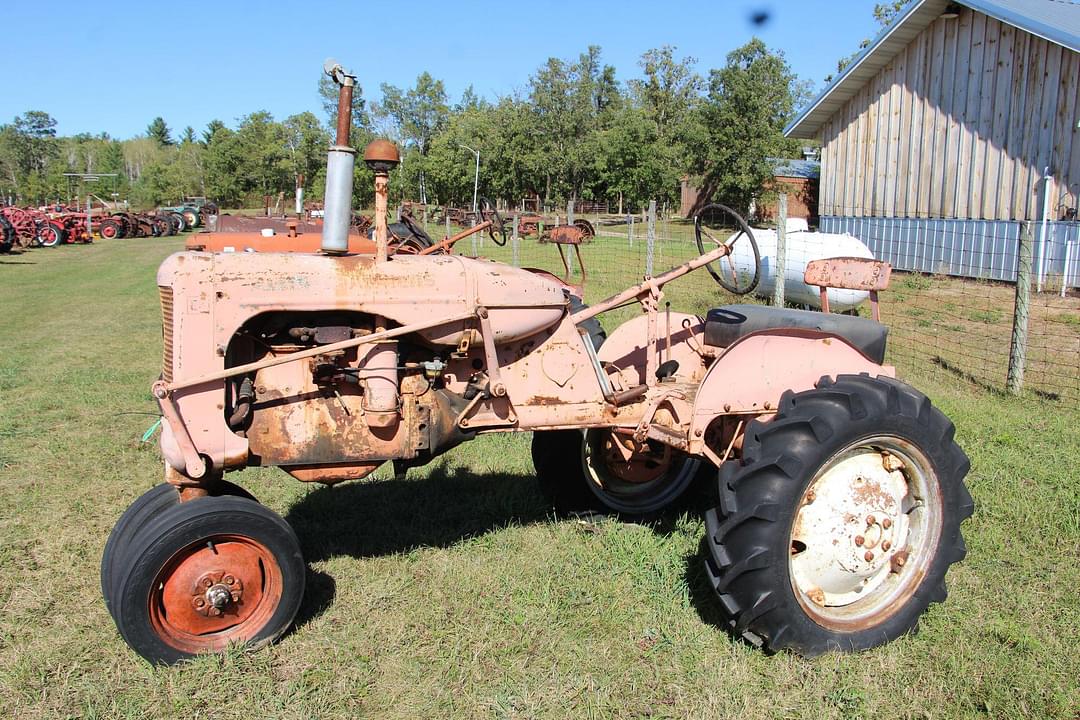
[{"x1": 821, "y1": 8, "x2": 1080, "y2": 220}]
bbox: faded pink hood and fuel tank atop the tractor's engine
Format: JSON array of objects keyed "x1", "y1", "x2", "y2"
[{"x1": 158, "y1": 252, "x2": 567, "y2": 345}]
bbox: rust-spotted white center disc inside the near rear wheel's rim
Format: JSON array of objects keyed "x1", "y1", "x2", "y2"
[{"x1": 791, "y1": 448, "x2": 916, "y2": 608}]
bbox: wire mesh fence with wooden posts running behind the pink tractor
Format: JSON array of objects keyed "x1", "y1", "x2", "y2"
[{"x1": 426, "y1": 199, "x2": 1080, "y2": 407}]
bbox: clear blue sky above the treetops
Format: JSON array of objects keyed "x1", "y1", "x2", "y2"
[{"x1": 0, "y1": 0, "x2": 877, "y2": 138}]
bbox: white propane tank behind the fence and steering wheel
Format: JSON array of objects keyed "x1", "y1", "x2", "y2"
[{"x1": 720, "y1": 218, "x2": 874, "y2": 312}]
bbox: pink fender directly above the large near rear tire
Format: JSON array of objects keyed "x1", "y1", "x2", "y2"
[{"x1": 691, "y1": 328, "x2": 896, "y2": 438}]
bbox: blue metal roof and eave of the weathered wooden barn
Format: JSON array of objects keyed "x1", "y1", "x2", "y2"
[{"x1": 784, "y1": 0, "x2": 1080, "y2": 138}]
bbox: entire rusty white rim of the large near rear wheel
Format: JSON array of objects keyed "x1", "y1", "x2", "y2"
[{"x1": 788, "y1": 436, "x2": 942, "y2": 630}]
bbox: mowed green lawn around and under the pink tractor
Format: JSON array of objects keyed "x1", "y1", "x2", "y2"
[{"x1": 0, "y1": 239, "x2": 1080, "y2": 720}]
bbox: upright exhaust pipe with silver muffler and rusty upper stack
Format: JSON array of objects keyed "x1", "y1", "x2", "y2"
[{"x1": 323, "y1": 59, "x2": 356, "y2": 255}]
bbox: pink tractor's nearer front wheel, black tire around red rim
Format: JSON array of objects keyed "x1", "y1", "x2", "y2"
[{"x1": 112, "y1": 497, "x2": 306, "y2": 664}]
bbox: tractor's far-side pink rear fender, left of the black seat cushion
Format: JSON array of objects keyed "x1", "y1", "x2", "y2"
[{"x1": 597, "y1": 311, "x2": 707, "y2": 390}]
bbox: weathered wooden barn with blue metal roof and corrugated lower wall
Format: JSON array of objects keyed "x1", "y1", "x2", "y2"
[{"x1": 785, "y1": 0, "x2": 1080, "y2": 287}]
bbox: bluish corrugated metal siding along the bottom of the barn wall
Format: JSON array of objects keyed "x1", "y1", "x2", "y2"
[{"x1": 821, "y1": 216, "x2": 1080, "y2": 287}]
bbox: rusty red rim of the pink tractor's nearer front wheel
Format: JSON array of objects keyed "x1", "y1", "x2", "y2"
[{"x1": 149, "y1": 534, "x2": 283, "y2": 653}]
